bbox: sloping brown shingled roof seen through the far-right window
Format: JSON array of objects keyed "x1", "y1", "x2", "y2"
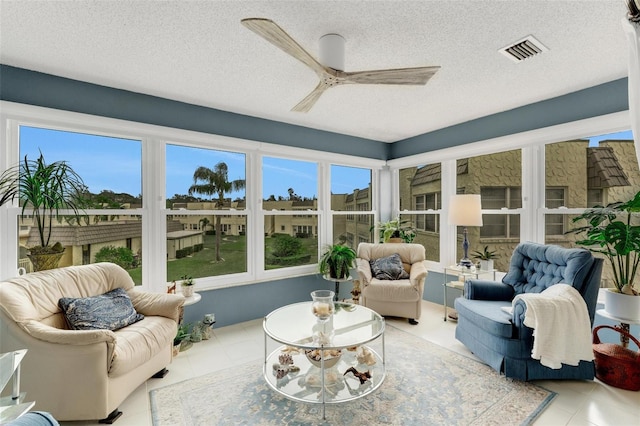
[{"x1": 587, "y1": 147, "x2": 631, "y2": 189}]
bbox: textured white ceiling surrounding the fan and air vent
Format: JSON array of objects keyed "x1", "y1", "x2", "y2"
[{"x1": 0, "y1": 0, "x2": 627, "y2": 142}]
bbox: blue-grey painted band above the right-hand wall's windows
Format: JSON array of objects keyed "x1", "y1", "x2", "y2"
[{"x1": 389, "y1": 78, "x2": 629, "y2": 159}]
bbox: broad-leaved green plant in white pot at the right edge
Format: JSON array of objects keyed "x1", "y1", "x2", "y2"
[{"x1": 567, "y1": 192, "x2": 640, "y2": 319}]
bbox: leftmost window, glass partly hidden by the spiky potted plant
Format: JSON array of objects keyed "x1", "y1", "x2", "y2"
[{"x1": 18, "y1": 126, "x2": 143, "y2": 284}]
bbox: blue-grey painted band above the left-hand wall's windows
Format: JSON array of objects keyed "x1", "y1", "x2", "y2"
[{"x1": 0, "y1": 65, "x2": 390, "y2": 160}]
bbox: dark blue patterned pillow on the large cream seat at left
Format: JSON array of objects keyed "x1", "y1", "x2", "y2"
[{"x1": 58, "y1": 288, "x2": 144, "y2": 331}]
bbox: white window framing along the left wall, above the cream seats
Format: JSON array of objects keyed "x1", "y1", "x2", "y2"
[{"x1": 0, "y1": 101, "x2": 385, "y2": 292}]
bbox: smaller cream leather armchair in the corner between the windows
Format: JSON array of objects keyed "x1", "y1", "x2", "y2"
[{"x1": 356, "y1": 243, "x2": 427, "y2": 324}]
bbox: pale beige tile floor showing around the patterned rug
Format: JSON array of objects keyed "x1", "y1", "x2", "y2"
[{"x1": 63, "y1": 301, "x2": 640, "y2": 426}]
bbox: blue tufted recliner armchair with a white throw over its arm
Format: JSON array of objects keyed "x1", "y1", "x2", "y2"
[{"x1": 455, "y1": 243, "x2": 602, "y2": 380}]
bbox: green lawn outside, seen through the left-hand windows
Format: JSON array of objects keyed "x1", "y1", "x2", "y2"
[{"x1": 128, "y1": 235, "x2": 318, "y2": 285}]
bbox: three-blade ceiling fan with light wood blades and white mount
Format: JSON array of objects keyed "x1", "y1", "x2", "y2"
[{"x1": 241, "y1": 18, "x2": 440, "y2": 112}]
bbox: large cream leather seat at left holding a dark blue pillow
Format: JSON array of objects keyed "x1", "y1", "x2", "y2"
[{"x1": 0, "y1": 263, "x2": 184, "y2": 423}]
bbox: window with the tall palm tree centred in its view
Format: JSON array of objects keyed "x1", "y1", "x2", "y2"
[{"x1": 165, "y1": 144, "x2": 247, "y2": 281}]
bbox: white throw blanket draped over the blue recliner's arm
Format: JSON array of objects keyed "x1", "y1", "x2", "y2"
[{"x1": 512, "y1": 284, "x2": 594, "y2": 369}]
